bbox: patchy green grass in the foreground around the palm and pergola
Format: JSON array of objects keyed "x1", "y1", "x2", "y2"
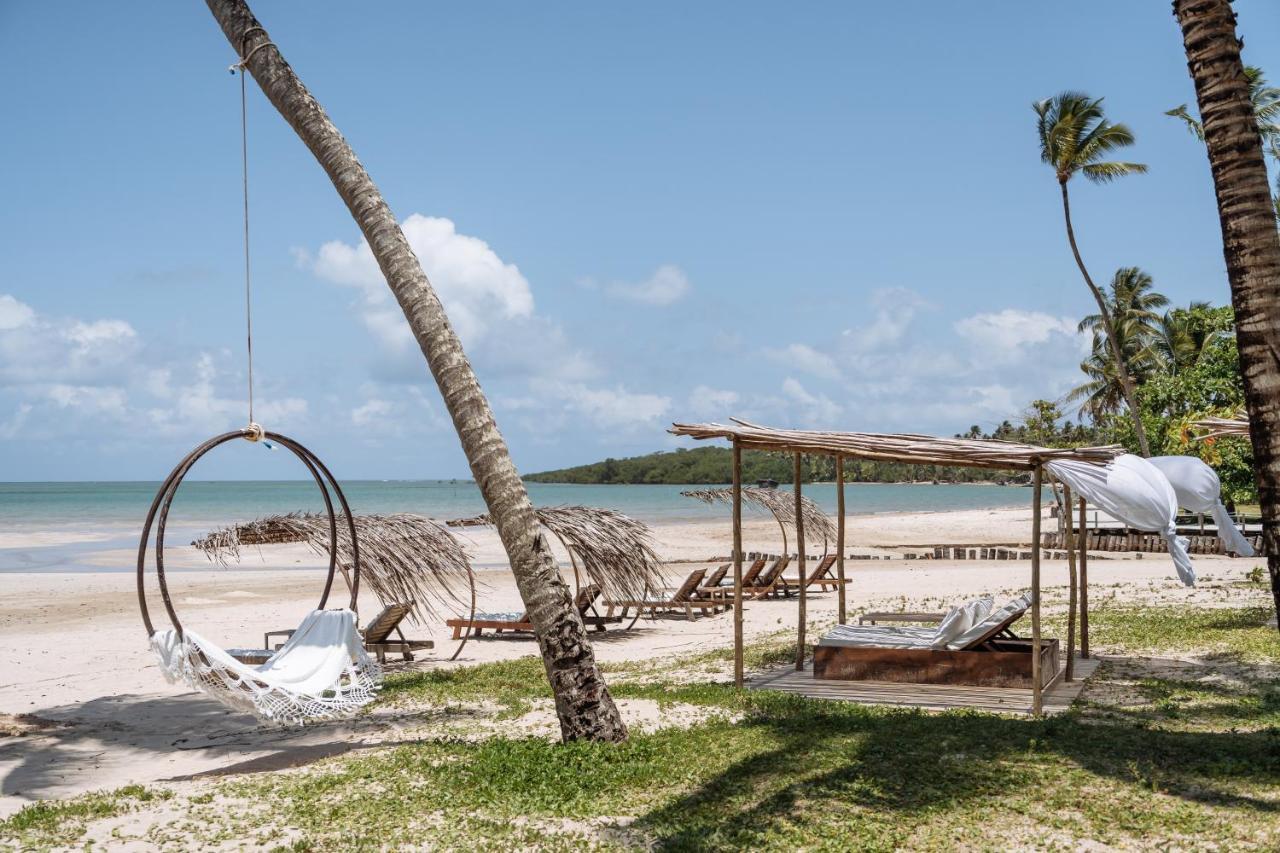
[{"x1": 10, "y1": 605, "x2": 1280, "y2": 850}]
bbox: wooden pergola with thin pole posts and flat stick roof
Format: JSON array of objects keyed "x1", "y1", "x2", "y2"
[{"x1": 669, "y1": 419, "x2": 1124, "y2": 715}]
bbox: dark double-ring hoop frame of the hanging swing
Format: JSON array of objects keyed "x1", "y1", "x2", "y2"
[{"x1": 137, "y1": 424, "x2": 360, "y2": 638}]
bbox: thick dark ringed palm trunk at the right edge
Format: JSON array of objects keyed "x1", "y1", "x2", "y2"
[{"x1": 1174, "y1": 0, "x2": 1280, "y2": 625}]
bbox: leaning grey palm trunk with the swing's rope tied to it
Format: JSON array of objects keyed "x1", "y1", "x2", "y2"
[{"x1": 206, "y1": 0, "x2": 626, "y2": 740}]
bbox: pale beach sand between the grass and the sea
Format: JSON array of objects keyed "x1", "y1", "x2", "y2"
[{"x1": 0, "y1": 510, "x2": 1253, "y2": 816}]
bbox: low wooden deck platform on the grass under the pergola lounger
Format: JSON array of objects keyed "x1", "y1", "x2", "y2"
[{"x1": 746, "y1": 657, "x2": 1100, "y2": 715}]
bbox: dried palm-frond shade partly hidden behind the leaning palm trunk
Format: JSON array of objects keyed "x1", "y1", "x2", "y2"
[{"x1": 448, "y1": 506, "x2": 666, "y2": 599}]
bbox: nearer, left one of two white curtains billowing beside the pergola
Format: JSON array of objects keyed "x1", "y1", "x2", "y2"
[{"x1": 1044, "y1": 453, "x2": 1196, "y2": 587}]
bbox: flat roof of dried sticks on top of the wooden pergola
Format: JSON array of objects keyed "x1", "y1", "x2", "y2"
[{"x1": 668, "y1": 418, "x2": 1124, "y2": 471}]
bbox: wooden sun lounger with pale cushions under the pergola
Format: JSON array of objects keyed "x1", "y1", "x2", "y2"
[{"x1": 813, "y1": 593, "x2": 1059, "y2": 688}]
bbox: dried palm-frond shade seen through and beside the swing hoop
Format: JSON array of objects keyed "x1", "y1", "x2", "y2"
[{"x1": 191, "y1": 512, "x2": 474, "y2": 622}]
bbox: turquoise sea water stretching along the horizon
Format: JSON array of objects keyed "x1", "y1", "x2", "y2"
[{"x1": 0, "y1": 480, "x2": 1028, "y2": 573}]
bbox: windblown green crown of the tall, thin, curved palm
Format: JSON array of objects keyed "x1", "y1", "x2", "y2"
[{"x1": 1032, "y1": 92, "x2": 1147, "y2": 183}]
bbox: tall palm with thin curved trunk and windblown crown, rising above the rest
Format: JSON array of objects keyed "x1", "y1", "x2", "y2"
[{"x1": 1032, "y1": 92, "x2": 1151, "y2": 456}]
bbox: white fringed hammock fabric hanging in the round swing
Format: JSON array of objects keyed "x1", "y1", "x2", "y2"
[{"x1": 151, "y1": 610, "x2": 383, "y2": 725}]
